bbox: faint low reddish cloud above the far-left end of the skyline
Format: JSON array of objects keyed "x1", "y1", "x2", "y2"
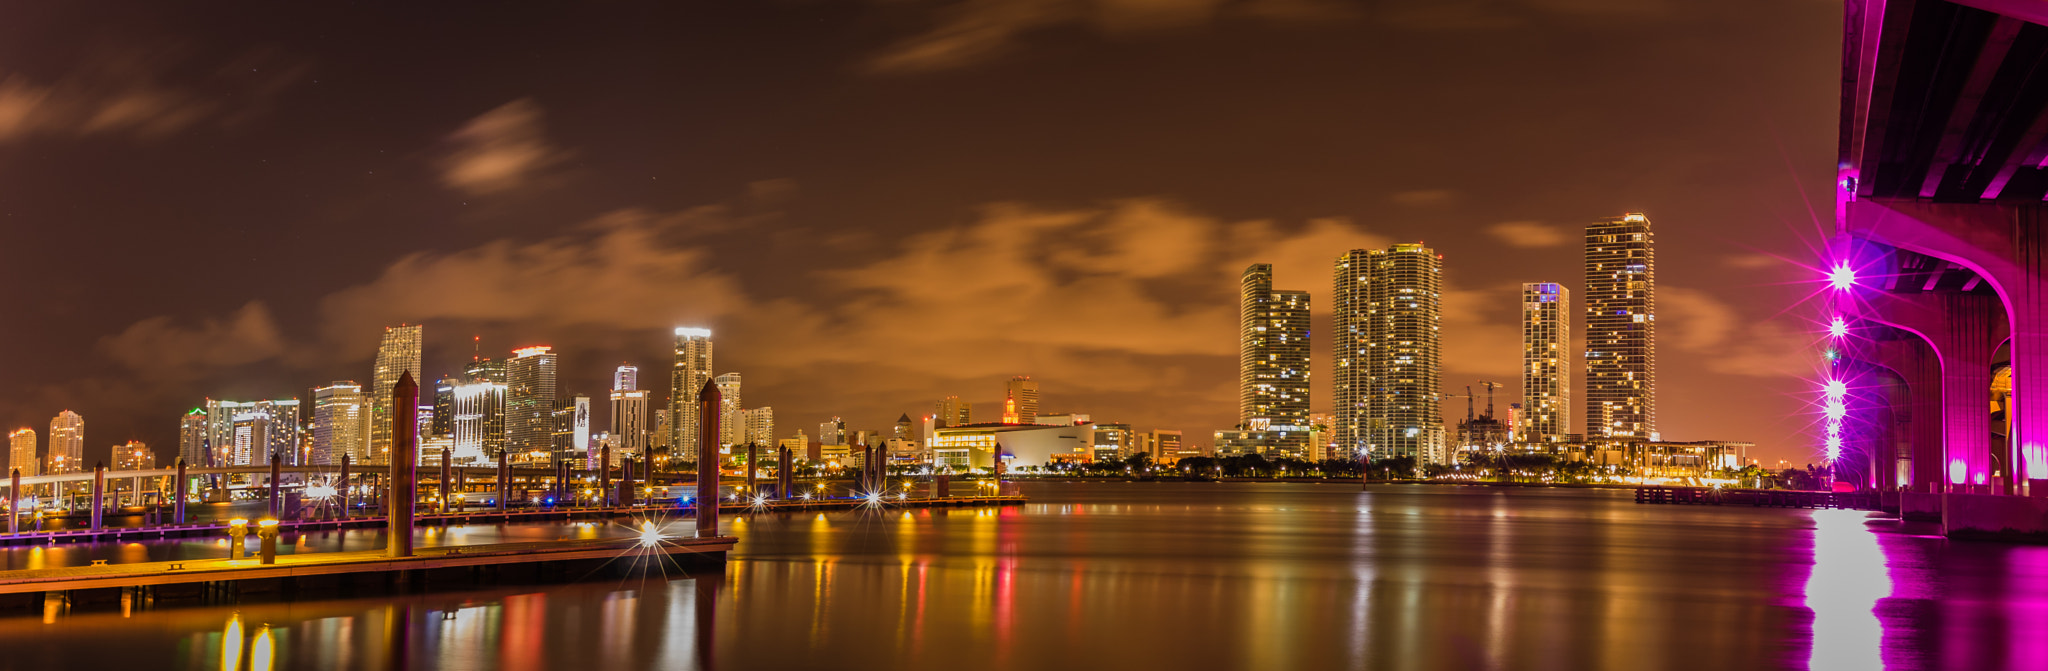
[{"x1": 98, "y1": 301, "x2": 285, "y2": 381}]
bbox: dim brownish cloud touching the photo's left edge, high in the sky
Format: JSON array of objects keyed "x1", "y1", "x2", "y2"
[{"x1": 0, "y1": 49, "x2": 305, "y2": 141}]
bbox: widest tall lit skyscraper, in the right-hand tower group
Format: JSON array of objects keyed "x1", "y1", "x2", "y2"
[{"x1": 1331, "y1": 243, "x2": 1450, "y2": 462}]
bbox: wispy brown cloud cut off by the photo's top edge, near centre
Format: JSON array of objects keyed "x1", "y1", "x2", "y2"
[{"x1": 866, "y1": 0, "x2": 1358, "y2": 74}]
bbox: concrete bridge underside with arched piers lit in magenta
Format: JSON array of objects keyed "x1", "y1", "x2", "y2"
[{"x1": 1829, "y1": 0, "x2": 2048, "y2": 532}]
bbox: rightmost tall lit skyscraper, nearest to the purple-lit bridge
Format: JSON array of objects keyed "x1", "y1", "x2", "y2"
[{"x1": 1585, "y1": 213, "x2": 1657, "y2": 442}]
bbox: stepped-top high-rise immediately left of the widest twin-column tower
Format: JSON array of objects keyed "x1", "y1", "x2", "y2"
[{"x1": 1221, "y1": 264, "x2": 1309, "y2": 456}]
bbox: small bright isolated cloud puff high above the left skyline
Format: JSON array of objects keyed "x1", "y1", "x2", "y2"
[{"x1": 440, "y1": 98, "x2": 567, "y2": 196}]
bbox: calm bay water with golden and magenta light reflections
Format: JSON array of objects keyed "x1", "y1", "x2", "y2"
[{"x1": 0, "y1": 483, "x2": 2048, "y2": 671}]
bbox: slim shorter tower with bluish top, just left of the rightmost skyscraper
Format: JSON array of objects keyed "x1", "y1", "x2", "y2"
[{"x1": 1509, "y1": 282, "x2": 1571, "y2": 442}]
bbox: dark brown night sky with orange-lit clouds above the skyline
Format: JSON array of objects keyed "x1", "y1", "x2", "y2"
[{"x1": 0, "y1": 0, "x2": 1841, "y2": 462}]
